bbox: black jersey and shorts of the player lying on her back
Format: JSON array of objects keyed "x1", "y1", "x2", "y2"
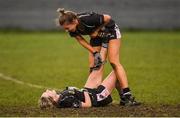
[{"x1": 57, "y1": 85, "x2": 112, "y2": 108}]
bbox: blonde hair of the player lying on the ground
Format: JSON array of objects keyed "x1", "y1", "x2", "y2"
[{"x1": 38, "y1": 97, "x2": 55, "y2": 109}]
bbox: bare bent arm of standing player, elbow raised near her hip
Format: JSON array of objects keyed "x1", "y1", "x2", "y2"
[{"x1": 90, "y1": 14, "x2": 111, "y2": 38}]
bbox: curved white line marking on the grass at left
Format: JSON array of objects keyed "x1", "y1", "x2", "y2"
[{"x1": 0, "y1": 73, "x2": 59, "y2": 90}]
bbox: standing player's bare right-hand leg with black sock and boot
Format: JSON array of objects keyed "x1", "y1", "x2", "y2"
[{"x1": 108, "y1": 39, "x2": 140, "y2": 106}]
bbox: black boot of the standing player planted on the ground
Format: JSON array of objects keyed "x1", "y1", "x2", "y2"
[{"x1": 120, "y1": 94, "x2": 141, "y2": 106}]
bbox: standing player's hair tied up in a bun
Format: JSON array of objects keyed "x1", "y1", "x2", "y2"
[{"x1": 57, "y1": 8, "x2": 77, "y2": 25}]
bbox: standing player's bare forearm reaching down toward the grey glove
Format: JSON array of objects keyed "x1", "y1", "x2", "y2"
[{"x1": 75, "y1": 36, "x2": 96, "y2": 53}]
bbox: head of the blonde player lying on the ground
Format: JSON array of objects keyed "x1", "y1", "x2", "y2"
[{"x1": 39, "y1": 89, "x2": 58, "y2": 109}]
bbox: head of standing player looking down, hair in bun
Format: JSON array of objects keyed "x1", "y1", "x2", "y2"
[{"x1": 57, "y1": 8, "x2": 78, "y2": 32}]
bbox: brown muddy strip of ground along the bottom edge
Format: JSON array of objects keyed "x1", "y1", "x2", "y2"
[{"x1": 0, "y1": 104, "x2": 180, "y2": 117}]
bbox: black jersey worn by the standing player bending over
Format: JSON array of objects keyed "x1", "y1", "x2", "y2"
[{"x1": 69, "y1": 12, "x2": 115, "y2": 37}]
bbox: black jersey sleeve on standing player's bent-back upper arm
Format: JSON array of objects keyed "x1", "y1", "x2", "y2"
[{"x1": 82, "y1": 12, "x2": 104, "y2": 26}]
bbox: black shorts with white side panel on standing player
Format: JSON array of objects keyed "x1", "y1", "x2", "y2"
[{"x1": 90, "y1": 25, "x2": 121, "y2": 48}]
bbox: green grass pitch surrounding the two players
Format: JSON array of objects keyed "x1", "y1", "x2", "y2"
[{"x1": 0, "y1": 32, "x2": 180, "y2": 116}]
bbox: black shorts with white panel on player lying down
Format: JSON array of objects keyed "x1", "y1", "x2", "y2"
[{"x1": 85, "y1": 85, "x2": 112, "y2": 107}]
